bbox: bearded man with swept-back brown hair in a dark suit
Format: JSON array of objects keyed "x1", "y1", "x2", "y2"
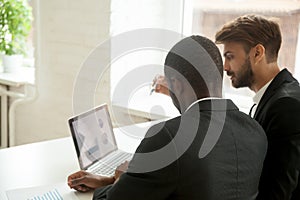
[{"x1": 216, "y1": 15, "x2": 300, "y2": 200}]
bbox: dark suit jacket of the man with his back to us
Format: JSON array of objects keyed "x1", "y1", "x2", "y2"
[{"x1": 94, "y1": 99, "x2": 267, "y2": 200}]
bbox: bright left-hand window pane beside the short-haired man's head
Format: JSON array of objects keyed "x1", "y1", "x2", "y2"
[{"x1": 111, "y1": 0, "x2": 184, "y2": 115}]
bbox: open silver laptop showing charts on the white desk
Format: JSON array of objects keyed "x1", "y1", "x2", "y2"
[{"x1": 68, "y1": 104, "x2": 132, "y2": 176}]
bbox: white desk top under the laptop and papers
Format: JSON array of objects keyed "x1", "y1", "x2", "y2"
[{"x1": 0, "y1": 122, "x2": 156, "y2": 200}]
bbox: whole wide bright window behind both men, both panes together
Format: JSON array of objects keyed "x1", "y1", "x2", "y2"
[{"x1": 111, "y1": 0, "x2": 300, "y2": 113}]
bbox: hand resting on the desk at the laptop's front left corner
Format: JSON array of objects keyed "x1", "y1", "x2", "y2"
[{"x1": 68, "y1": 171, "x2": 115, "y2": 192}]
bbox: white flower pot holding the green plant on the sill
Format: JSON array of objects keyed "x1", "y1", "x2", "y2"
[{"x1": 2, "y1": 55, "x2": 23, "y2": 73}]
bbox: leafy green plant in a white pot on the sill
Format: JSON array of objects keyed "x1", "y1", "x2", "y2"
[{"x1": 0, "y1": 0, "x2": 32, "y2": 72}]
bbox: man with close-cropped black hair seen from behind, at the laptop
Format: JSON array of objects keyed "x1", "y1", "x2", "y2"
[{"x1": 69, "y1": 36, "x2": 267, "y2": 200}]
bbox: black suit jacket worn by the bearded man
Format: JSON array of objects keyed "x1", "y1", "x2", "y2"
[{"x1": 254, "y1": 69, "x2": 300, "y2": 200}]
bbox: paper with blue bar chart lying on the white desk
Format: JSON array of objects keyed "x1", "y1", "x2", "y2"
[{"x1": 6, "y1": 183, "x2": 78, "y2": 200}]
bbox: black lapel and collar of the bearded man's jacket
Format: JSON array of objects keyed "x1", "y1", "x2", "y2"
[{"x1": 254, "y1": 69, "x2": 296, "y2": 119}]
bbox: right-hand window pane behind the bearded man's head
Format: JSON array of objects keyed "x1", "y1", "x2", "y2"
[{"x1": 192, "y1": 0, "x2": 300, "y2": 113}]
